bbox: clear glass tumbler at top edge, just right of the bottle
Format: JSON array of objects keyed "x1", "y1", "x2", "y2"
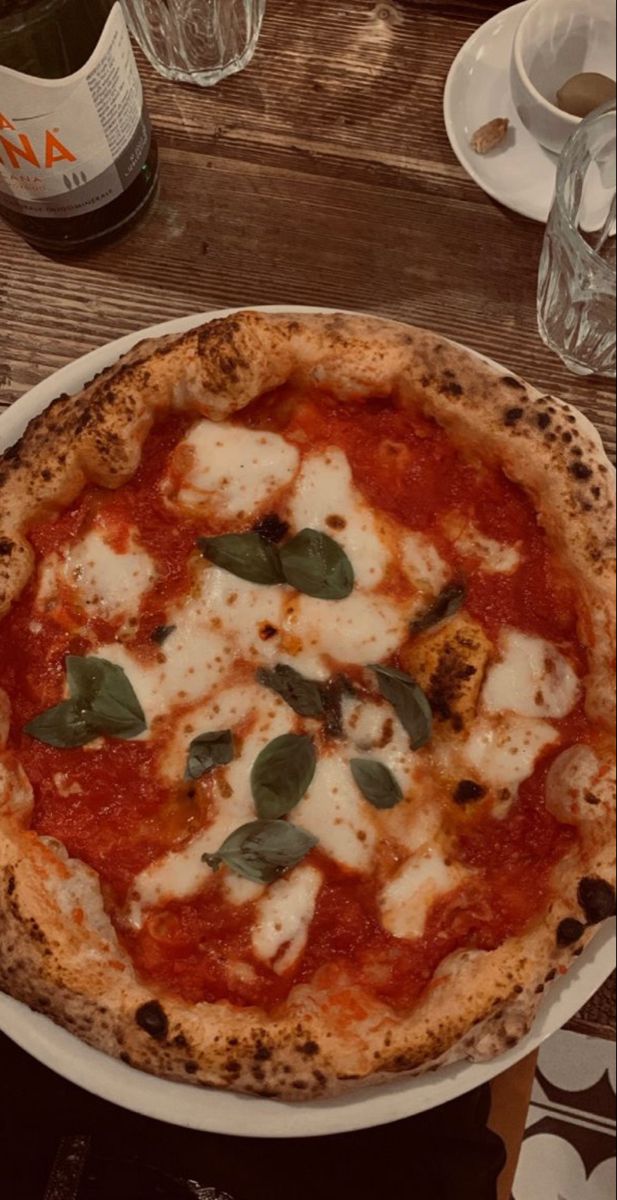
[{"x1": 124, "y1": 0, "x2": 265, "y2": 88}]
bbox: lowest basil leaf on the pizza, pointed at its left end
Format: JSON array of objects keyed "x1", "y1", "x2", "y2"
[{"x1": 202, "y1": 821, "x2": 318, "y2": 883}]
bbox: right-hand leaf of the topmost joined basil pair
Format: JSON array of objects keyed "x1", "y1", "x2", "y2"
[{"x1": 280, "y1": 529, "x2": 355, "y2": 600}]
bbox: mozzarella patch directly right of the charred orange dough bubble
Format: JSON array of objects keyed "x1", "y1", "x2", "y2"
[{"x1": 483, "y1": 629, "x2": 580, "y2": 719}]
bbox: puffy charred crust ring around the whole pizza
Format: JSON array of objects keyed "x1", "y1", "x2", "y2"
[{"x1": 0, "y1": 312, "x2": 615, "y2": 1099}]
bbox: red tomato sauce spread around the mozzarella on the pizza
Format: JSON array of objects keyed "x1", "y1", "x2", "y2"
[{"x1": 0, "y1": 389, "x2": 592, "y2": 1009}]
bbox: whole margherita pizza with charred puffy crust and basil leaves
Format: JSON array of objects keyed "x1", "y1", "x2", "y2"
[{"x1": 0, "y1": 312, "x2": 615, "y2": 1099}]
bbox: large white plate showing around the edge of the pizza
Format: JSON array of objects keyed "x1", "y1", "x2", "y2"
[{"x1": 0, "y1": 305, "x2": 615, "y2": 1138}]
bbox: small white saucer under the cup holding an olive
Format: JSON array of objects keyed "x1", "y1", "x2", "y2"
[{"x1": 443, "y1": 0, "x2": 558, "y2": 222}]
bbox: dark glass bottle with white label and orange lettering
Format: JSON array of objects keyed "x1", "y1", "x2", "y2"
[{"x1": 0, "y1": 0, "x2": 157, "y2": 253}]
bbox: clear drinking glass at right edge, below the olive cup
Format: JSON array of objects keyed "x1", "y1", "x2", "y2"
[{"x1": 538, "y1": 101, "x2": 616, "y2": 376}]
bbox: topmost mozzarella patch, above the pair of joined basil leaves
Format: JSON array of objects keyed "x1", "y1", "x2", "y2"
[{"x1": 166, "y1": 420, "x2": 299, "y2": 520}]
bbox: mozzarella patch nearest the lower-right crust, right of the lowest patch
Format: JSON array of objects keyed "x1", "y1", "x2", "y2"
[{"x1": 379, "y1": 846, "x2": 468, "y2": 940}]
